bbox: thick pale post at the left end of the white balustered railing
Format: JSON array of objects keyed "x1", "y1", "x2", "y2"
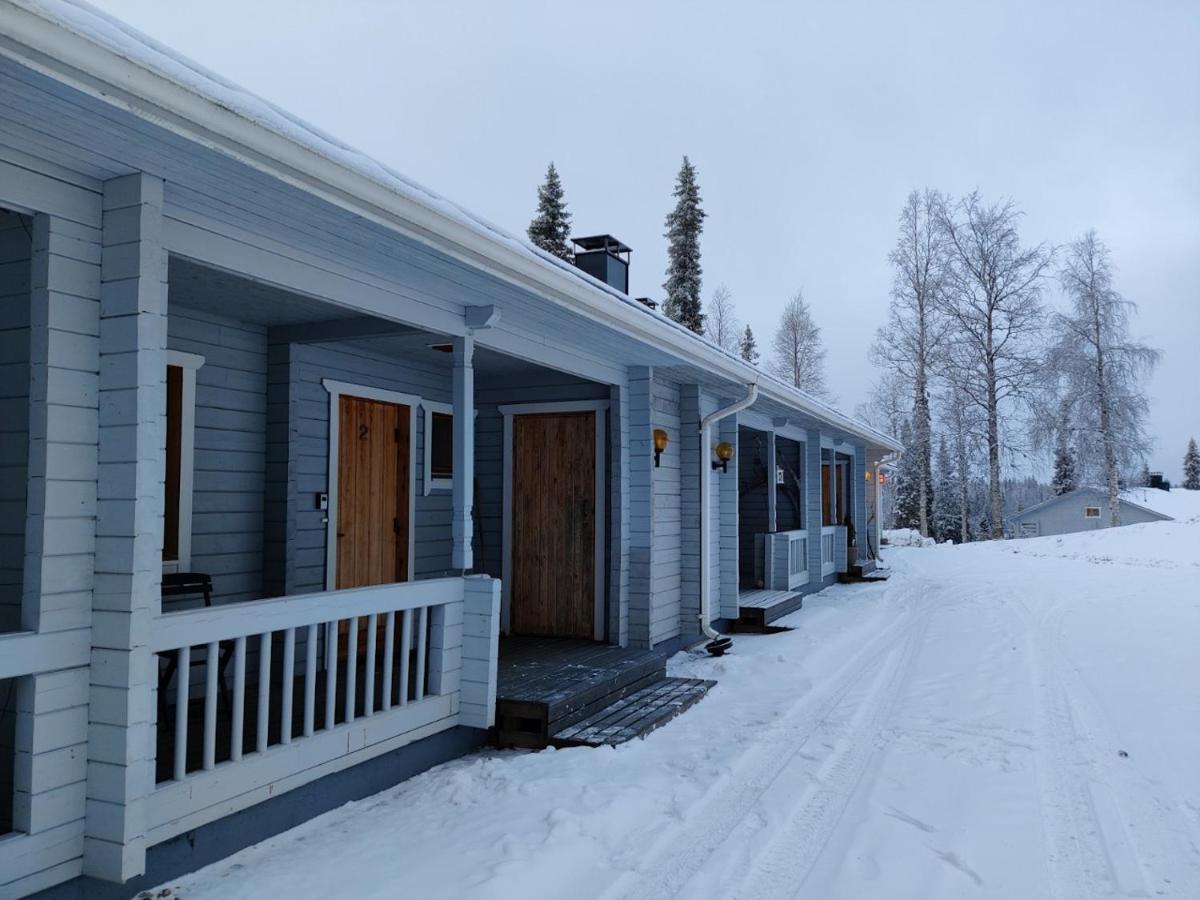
[{"x1": 84, "y1": 173, "x2": 166, "y2": 882}]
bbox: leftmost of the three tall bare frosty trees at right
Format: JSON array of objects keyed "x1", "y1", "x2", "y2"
[{"x1": 871, "y1": 188, "x2": 947, "y2": 538}]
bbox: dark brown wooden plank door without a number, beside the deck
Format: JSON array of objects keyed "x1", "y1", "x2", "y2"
[{"x1": 509, "y1": 412, "x2": 596, "y2": 638}]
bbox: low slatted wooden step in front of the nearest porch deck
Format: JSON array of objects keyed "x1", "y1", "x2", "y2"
[{"x1": 550, "y1": 678, "x2": 716, "y2": 746}]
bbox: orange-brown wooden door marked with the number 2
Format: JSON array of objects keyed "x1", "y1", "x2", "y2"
[{"x1": 336, "y1": 396, "x2": 412, "y2": 589}]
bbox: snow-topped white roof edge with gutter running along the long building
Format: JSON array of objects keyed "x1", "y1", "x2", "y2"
[{"x1": 0, "y1": 0, "x2": 900, "y2": 450}]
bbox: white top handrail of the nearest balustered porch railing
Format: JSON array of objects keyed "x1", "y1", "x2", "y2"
[{"x1": 150, "y1": 577, "x2": 464, "y2": 653}]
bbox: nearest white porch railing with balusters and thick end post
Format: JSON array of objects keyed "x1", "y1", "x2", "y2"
[{"x1": 146, "y1": 577, "x2": 499, "y2": 844}]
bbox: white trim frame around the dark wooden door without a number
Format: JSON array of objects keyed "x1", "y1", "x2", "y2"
[{"x1": 497, "y1": 400, "x2": 608, "y2": 641}]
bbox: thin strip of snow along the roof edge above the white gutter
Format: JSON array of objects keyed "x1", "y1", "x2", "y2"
[{"x1": 12, "y1": 0, "x2": 895, "y2": 446}]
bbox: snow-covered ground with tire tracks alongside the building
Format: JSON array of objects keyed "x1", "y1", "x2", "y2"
[{"x1": 154, "y1": 504, "x2": 1200, "y2": 900}]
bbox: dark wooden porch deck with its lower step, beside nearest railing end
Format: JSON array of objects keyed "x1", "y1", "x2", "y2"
[{"x1": 496, "y1": 637, "x2": 715, "y2": 749}]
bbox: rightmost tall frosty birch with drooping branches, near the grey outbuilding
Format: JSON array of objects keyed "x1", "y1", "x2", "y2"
[{"x1": 1050, "y1": 230, "x2": 1159, "y2": 526}]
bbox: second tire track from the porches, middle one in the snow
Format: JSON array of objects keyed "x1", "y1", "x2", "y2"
[{"x1": 733, "y1": 595, "x2": 936, "y2": 900}]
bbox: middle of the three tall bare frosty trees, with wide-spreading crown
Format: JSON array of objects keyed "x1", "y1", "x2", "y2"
[{"x1": 936, "y1": 192, "x2": 1054, "y2": 538}]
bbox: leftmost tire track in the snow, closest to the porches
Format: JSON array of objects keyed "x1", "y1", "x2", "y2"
[{"x1": 602, "y1": 592, "x2": 929, "y2": 900}]
